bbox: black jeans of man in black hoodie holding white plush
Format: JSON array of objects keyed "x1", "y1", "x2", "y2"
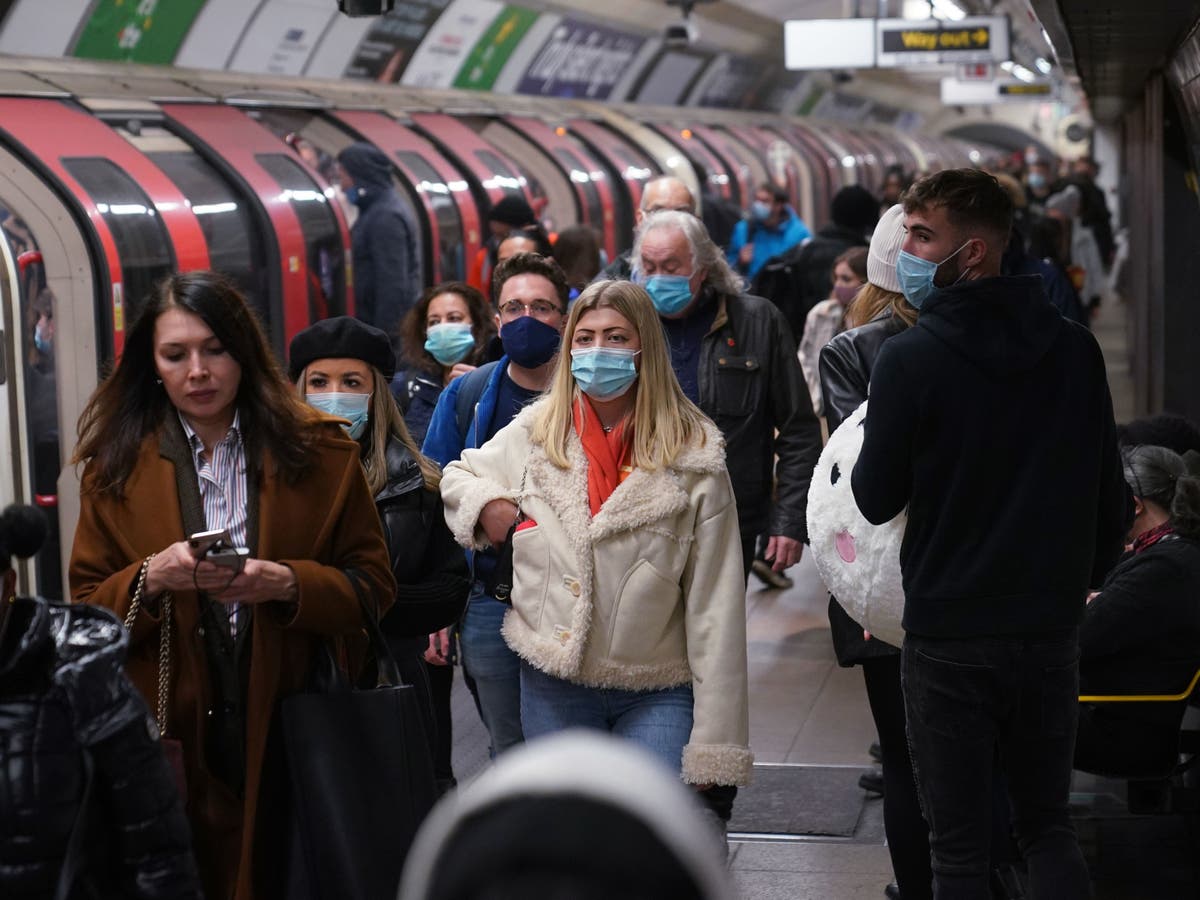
[{"x1": 902, "y1": 631, "x2": 1091, "y2": 900}]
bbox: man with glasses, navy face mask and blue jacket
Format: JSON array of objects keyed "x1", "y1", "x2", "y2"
[{"x1": 421, "y1": 253, "x2": 570, "y2": 757}]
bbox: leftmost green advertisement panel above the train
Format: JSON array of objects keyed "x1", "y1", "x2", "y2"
[{"x1": 71, "y1": 0, "x2": 204, "y2": 66}]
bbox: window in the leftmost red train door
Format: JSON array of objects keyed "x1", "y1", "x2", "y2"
[{"x1": 62, "y1": 156, "x2": 176, "y2": 326}]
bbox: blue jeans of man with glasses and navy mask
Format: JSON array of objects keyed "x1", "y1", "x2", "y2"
[{"x1": 458, "y1": 581, "x2": 523, "y2": 758}]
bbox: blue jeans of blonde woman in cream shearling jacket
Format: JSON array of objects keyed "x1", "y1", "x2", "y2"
[{"x1": 521, "y1": 662, "x2": 692, "y2": 772}]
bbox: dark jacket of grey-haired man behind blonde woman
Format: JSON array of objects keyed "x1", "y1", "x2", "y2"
[{"x1": 698, "y1": 294, "x2": 821, "y2": 542}]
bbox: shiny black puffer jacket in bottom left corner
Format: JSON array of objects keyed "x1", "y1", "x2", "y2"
[{"x1": 0, "y1": 599, "x2": 200, "y2": 900}]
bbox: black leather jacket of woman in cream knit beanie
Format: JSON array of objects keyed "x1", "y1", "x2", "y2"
[{"x1": 817, "y1": 311, "x2": 907, "y2": 666}]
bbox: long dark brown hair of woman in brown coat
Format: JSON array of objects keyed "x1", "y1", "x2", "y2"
[{"x1": 72, "y1": 271, "x2": 317, "y2": 497}]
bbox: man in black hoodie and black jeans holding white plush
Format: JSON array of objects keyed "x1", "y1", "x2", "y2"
[{"x1": 851, "y1": 169, "x2": 1129, "y2": 900}]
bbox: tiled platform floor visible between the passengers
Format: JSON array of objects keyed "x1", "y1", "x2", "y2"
[{"x1": 444, "y1": 305, "x2": 1200, "y2": 900}]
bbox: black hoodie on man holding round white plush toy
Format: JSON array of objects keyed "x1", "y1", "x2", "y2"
[{"x1": 851, "y1": 276, "x2": 1132, "y2": 637}]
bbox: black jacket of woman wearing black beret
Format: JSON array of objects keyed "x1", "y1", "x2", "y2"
[{"x1": 376, "y1": 439, "x2": 470, "y2": 637}]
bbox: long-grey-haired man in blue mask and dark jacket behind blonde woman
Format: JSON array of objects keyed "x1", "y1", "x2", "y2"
[{"x1": 632, "y1": 211, "x2": 821, "y2": 588}]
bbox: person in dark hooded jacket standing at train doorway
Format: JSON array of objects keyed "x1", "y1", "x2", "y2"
[{"x1": 337, "y1": 142, "x2": 424, "y2": 344}]
